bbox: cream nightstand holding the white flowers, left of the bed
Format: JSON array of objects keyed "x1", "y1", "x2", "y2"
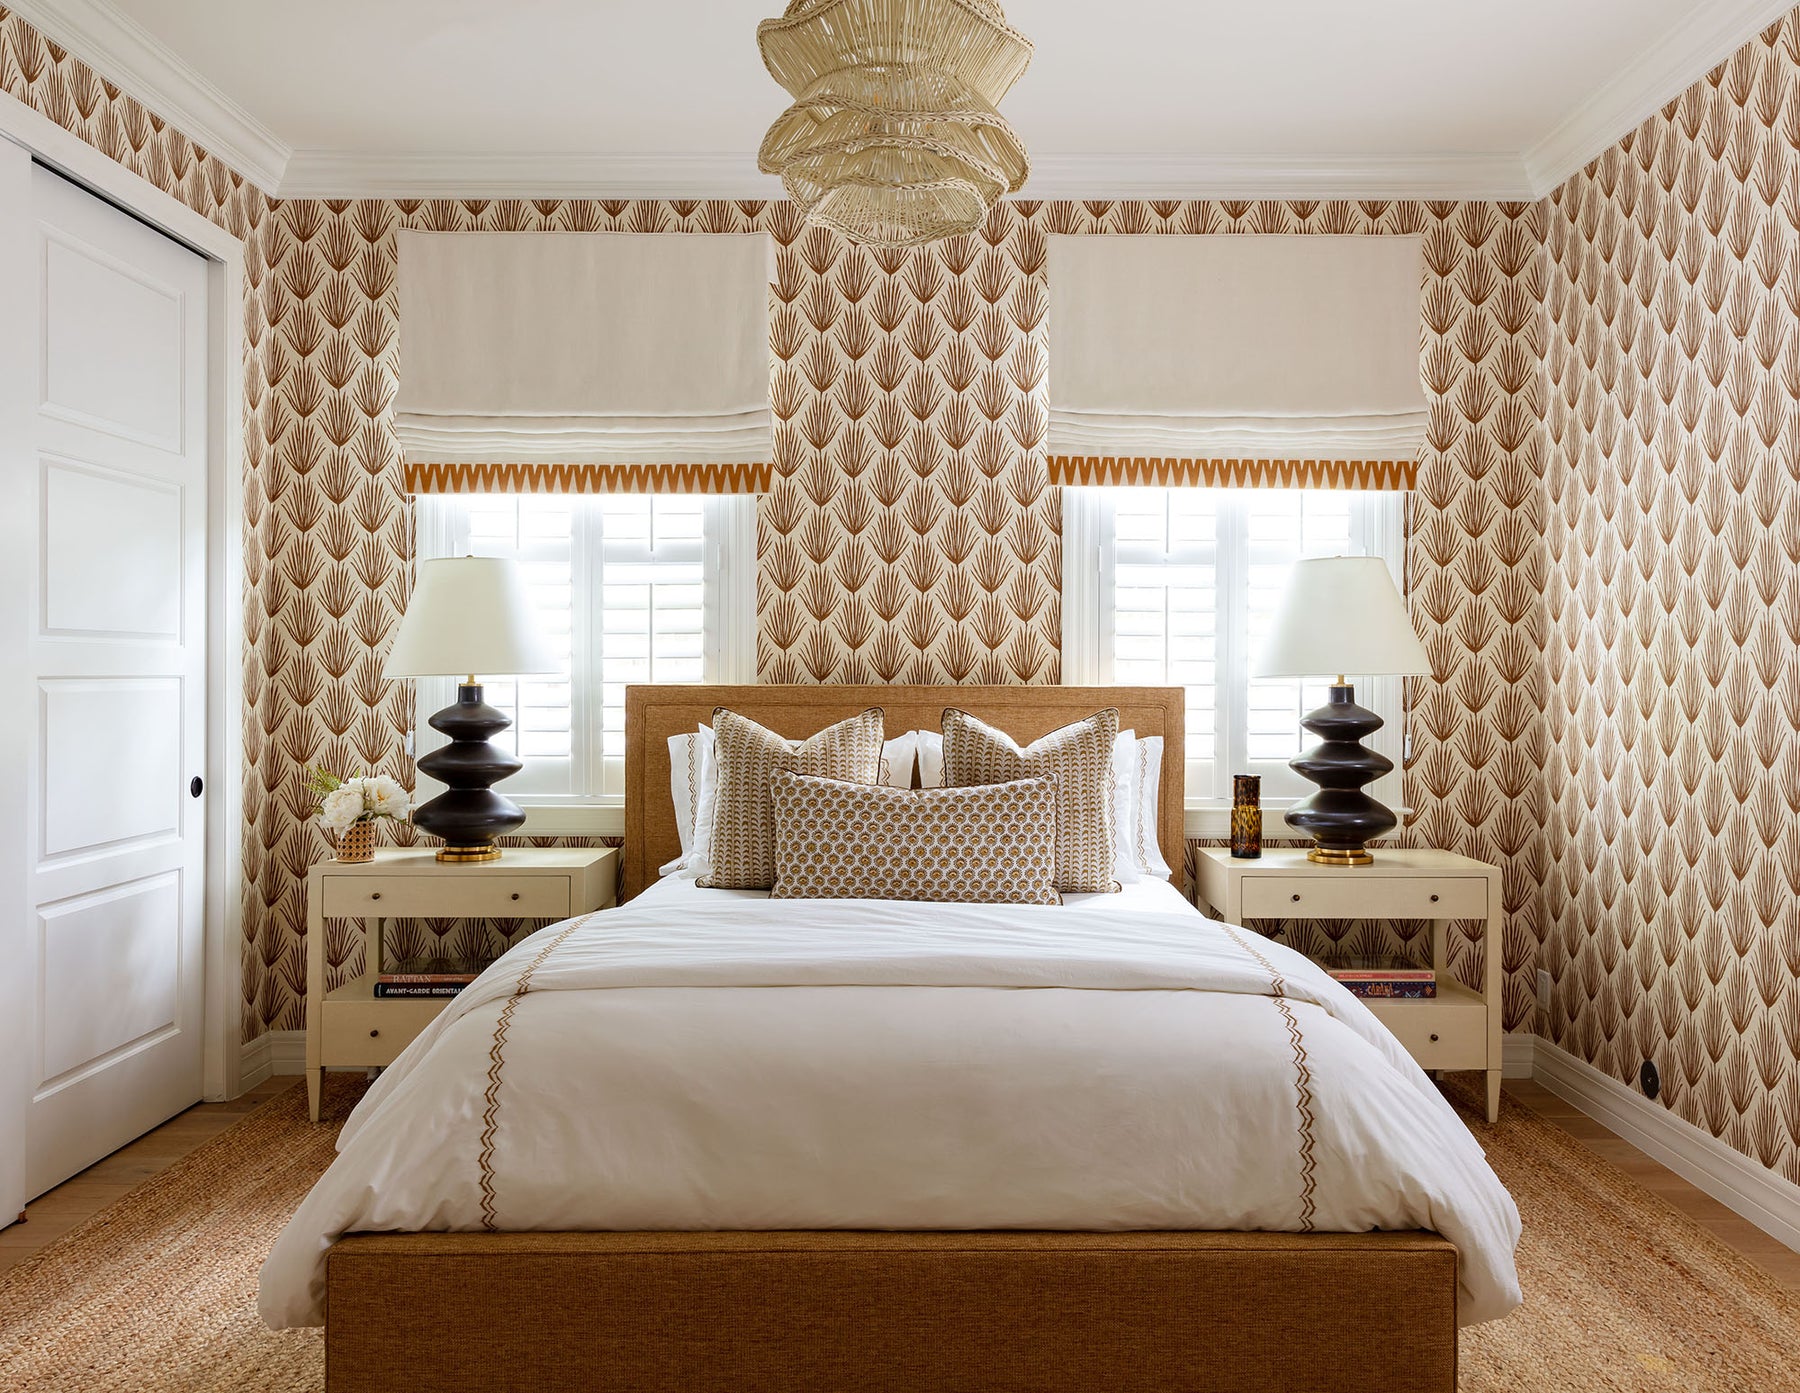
[{"x1": 306, "y1": 846, "x2": 619, "y2": 1121}]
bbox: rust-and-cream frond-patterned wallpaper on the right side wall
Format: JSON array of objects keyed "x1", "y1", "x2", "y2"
[{"x1": 1543, "y1": 14, "x2": 1800, "y2": 1181}]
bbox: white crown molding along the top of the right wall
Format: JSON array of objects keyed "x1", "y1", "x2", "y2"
[{"x1": 1523, "y1": 0, "x2": 1793, "y2": 196}]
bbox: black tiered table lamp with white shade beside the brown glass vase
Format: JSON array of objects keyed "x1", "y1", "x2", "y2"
[{"x1": 1251, "y1": 556, "x2": 1431, "y2": 866}]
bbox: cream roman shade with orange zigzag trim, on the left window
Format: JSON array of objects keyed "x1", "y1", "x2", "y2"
[{"x1": 394, "y1": 232, "x2": 772, "y2": 493}]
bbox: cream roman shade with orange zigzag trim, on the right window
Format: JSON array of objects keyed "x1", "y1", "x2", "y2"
[{"x1": 1048, "y1": 236, "x2": 1427, "y2": 488}]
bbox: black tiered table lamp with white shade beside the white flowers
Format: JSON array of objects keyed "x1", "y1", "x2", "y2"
[{"x1": 382, "y1": 556, "x2": 560, "y2": 862}]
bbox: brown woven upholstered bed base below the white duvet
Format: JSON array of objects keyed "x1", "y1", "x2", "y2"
[{"x1": 326, "y1": 1233, "x2": 1456, "y2": 1393}]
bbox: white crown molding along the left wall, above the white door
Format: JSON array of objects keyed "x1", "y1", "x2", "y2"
[{"x1": 5, "y1": 0, "x2": 290, "y2": 194}]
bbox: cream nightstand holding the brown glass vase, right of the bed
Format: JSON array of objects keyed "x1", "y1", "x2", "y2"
[{"x1": 1195, "y1": 846, "x2": 1503, "y2": 1121}]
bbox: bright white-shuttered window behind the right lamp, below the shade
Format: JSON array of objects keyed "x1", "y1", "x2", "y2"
[{"x1": 1064, "y1": 488, "x2": 1406, "y2": 824}]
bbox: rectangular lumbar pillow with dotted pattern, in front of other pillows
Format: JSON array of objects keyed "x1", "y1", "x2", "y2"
[{"x1": 769, "y1": 774, "x2": 1062, "y2": 905}]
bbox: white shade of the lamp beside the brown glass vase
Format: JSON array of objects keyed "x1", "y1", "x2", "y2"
[{"x1": 1251, "y1": 556, "x2": 1431, "y2": 677}]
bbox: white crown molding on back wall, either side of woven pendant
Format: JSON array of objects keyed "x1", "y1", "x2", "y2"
[{"x1": 279, "y1": 149, "x2": 1537, "y2": 200}]
